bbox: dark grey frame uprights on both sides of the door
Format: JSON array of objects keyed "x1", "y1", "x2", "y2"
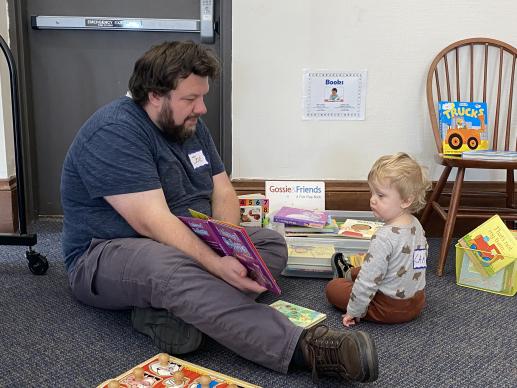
[{"x1": 7, "y1": 0, "x2": 232, "y2": 223}]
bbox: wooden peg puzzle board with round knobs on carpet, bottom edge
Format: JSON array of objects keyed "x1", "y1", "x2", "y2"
[{"x1": 97, "y1": 353, "x2": 260, "y2": 388}]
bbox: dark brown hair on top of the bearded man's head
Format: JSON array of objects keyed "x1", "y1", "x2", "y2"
[{"x1": 129, "y1": 41, "x2": 221, "y2": 106}]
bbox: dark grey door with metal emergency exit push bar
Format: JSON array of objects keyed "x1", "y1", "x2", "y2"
[{"x1": 11, "y1": 0, "x2": 231, "y2": 216}]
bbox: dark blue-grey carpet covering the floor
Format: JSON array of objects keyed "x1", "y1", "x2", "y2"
[{"x1": 0, "y1": 220, "x2": 517, "y2": 387}]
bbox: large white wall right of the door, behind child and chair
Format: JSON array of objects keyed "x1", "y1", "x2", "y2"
[{"x1": 232, "y1": 0, "x2": 517, "y2": 180}]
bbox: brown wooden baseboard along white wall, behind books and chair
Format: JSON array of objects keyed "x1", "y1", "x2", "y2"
[{"x1": 232, "y1": 179, "x2": 506, "y2": 237}]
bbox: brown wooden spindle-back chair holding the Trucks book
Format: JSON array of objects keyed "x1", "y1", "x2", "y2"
[{"x1": 421, "y1": 38, "x2": 517, "y2": 276}]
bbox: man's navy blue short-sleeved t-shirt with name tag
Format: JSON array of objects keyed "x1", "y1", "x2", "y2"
[{"x1": 61, "y1": 97, "x2": 224, "y2": 270}]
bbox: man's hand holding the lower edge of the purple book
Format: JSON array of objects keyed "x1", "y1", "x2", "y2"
[{"x1": 211, "y1": 256, "x2": 266, "y2": 294}]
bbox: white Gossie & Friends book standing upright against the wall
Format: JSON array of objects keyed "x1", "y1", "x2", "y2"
[{"x1": 266, "y1": 181, "x2": 325, "y2": 214}]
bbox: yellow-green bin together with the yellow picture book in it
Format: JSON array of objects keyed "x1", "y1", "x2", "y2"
[{"x1": 456, "y1": 214, "x2": 517, "y2": 295}]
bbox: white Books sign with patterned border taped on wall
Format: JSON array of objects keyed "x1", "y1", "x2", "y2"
[{"x1": 303, "y1": 70, "x2": 367, "y2": 120}]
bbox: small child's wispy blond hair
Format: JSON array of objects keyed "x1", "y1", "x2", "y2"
[{"x1": 368, "y1": 152, "x2": 431, "y2": 213}]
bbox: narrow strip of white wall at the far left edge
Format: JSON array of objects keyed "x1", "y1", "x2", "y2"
[{"x1": 0, "y1": 1, "x2": 15, "y2": 179}]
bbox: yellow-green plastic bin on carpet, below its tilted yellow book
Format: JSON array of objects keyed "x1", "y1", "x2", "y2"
[{"x1": 456, "y1": 244, "x2": 517, "y2": 296}]
